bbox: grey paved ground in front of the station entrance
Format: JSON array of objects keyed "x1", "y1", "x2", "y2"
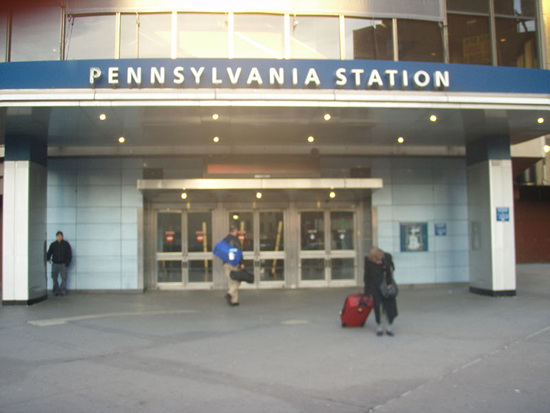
[{"x1": 0, "y1": 264, "x2": 550, "y2": 413}]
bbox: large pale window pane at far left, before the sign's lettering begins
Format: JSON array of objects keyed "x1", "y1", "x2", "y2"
[{"x1": 11, "y1": 7, "x2": 61, "y2": 62}]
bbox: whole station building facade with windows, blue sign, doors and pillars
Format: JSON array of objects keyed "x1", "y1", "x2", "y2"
[{"x1": 0, "y1": 0, "x2": 550, "y2": 303}]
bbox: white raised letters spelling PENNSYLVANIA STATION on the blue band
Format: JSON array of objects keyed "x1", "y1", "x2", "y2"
[{"x1": 89, "y1": 66, "x2": 451, "y2": 90}]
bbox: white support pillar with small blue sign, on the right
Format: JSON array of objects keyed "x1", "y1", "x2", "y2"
[{"x1": 466, "y1": 137, "x2": 516, "y2": 296}]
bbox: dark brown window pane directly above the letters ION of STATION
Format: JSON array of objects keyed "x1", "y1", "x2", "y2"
[{"x1": 397, "y1": 19, "x2": 443, "y2": 62}]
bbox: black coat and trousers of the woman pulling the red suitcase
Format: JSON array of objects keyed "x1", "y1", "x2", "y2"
[{"x1": 364, "y1": 253, "x2": 397, "y2": 324}]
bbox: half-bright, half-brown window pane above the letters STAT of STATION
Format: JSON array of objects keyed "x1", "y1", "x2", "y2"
[{"x1": 345, "y1": 18, "x2": 393, "y2": 60}]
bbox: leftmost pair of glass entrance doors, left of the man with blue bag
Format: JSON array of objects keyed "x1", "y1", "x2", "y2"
[{"x1": 156, "y1": 211, "x2": 216, "y2": 288}]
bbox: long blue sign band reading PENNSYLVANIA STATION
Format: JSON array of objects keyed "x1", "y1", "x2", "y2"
[{"x1": 0, "y1": 59, "x2": 550, "y2": 94}]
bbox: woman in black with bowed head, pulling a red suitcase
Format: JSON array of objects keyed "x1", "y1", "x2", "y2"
[{"x1": 364, "y1": 247, "x2": 397, "y2": 336}]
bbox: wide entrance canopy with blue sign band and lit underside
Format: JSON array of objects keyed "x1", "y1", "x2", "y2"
[{"x1": 0, "y1": 59, "x2": 550, "y2": 156}]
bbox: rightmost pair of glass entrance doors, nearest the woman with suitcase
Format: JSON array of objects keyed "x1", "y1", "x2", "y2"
[{"x1": 299, "y1": 211, "x2": 357, "y2": 285}]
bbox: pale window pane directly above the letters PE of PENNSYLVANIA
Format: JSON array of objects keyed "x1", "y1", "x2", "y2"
[{"x1": 65, "y1": 14, "x2": 116, "y2": 60}]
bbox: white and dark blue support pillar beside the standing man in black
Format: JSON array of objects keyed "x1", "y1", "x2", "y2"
[{"x1": 2, "y1": 136, "x2": 47, "y2": 305}]
